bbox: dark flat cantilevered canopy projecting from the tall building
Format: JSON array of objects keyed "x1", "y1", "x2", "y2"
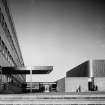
[{"x1": 2, "y1": 66, "x2": 53, "y2": 74}]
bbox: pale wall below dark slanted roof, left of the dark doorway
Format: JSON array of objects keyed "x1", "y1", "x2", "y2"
[{"x1": 65, "y1": 77, "x2": 88, "y2": 92}]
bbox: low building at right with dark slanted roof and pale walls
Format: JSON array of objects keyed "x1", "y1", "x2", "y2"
[{"x1": 57, "y1": 60, "x2": 105, "y2": 92}]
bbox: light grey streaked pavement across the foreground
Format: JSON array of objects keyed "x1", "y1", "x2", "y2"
[{"x1": 0, "y1": 92, "x2": 105, "y2": 105}]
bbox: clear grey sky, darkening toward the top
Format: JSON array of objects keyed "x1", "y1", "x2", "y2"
[{"x1": 9, "y1": 0, "x2": 105, "y2": 82}]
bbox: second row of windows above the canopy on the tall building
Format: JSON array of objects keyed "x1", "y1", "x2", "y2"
[{"x1": 0, "y1": 6, "x2": 19, "y2": 65}]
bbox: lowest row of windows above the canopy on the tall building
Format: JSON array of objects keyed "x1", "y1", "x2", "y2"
[{"x1": 0, "y1": 37, "x2": 16, "y2": 65}]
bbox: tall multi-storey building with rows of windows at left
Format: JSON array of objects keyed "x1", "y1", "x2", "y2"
[{"x1": 0, "y1": 0, "x2": 26, "y2": 93}]
